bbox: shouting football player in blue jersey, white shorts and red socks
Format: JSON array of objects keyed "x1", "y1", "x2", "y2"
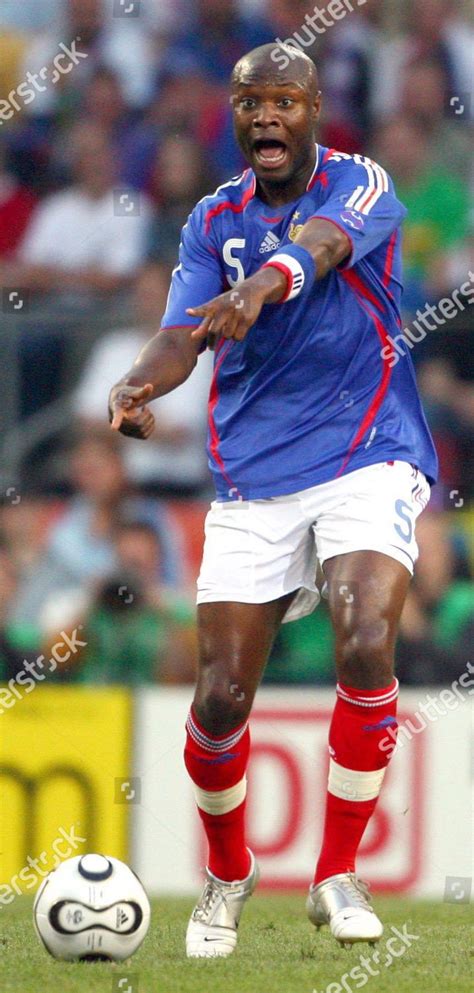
[{"x1": 109, "y1": 44, "x2": 437, "y2": 957}]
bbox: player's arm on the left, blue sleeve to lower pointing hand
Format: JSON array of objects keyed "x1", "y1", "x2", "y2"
[{"x1": 109, "y1": 204, "x2": 224, "y2": 439}]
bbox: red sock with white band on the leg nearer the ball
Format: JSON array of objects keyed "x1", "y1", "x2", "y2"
[{"x1": 184, "y1": 709, "x2": 250, "y2": 882}]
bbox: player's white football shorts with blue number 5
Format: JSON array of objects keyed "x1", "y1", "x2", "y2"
[{"x1": 197, "y1": 462, "x2": 430, "y2": 621}]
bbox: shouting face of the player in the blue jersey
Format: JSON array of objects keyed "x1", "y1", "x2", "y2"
[{"x1": 232, "y1": 82, "x2": 320, "y2": 184}]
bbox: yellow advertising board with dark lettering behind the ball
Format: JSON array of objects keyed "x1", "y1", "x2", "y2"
[{"x1": 0, "y1": 686, "x2": 132, "y2": 903}]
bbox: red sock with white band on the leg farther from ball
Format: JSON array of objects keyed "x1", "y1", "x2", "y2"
[{"x1": 314, "y1": 679, "x2": 398, "y2": 883}]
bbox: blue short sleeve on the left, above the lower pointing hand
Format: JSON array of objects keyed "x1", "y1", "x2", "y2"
[{"x1": 161, "y1": 205, "x2": 225, "y2": 328}]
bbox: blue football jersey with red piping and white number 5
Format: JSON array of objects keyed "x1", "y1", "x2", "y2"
[{"x1": 162, "y1": 146, "x2": 437, "y2": 500}]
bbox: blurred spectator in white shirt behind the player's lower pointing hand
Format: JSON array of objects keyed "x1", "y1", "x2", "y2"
[{"x1": 74, "y1": 264, "x2": 212, "y2": 496}]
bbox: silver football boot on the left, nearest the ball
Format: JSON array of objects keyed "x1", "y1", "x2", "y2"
[{"x1": 186, "y1": 849, "x2": 259, "y2": 958}]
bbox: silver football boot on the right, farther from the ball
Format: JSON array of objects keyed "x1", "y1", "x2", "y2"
[{"x1": 306, "y1": 872, "x2": 383, "y2": 948}]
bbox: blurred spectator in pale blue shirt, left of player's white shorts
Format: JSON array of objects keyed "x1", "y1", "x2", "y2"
[{"x1": 14, "y1": 426, "x2": 182, "y2": 629}]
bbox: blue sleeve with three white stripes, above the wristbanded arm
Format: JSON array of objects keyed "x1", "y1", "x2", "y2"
[{"x1": 313, "y1": 155, "x2": 407, "y2": 269}]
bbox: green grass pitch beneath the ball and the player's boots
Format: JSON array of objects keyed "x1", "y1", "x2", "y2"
[{"x1": 0, "y1": 894, "x2": 474, "y2": 993}]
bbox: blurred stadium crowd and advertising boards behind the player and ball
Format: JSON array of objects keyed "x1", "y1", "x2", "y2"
[{"x1": 0, "y1": 0, "x2": 474, "y2": 902}]
